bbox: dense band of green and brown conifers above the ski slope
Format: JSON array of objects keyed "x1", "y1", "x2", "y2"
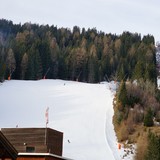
[{"x1": 0, "y1": 19, "x2": 156, "y2": 83}]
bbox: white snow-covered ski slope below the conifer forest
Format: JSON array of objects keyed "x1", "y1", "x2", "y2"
[{"x1": 0, "y1": 80, "x2": 133, "y2": 160}]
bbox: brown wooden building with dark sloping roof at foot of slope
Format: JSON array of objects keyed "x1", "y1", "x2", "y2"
[{"x1": 0, "y1": 128, "x2": 72, "y2": 160}]
